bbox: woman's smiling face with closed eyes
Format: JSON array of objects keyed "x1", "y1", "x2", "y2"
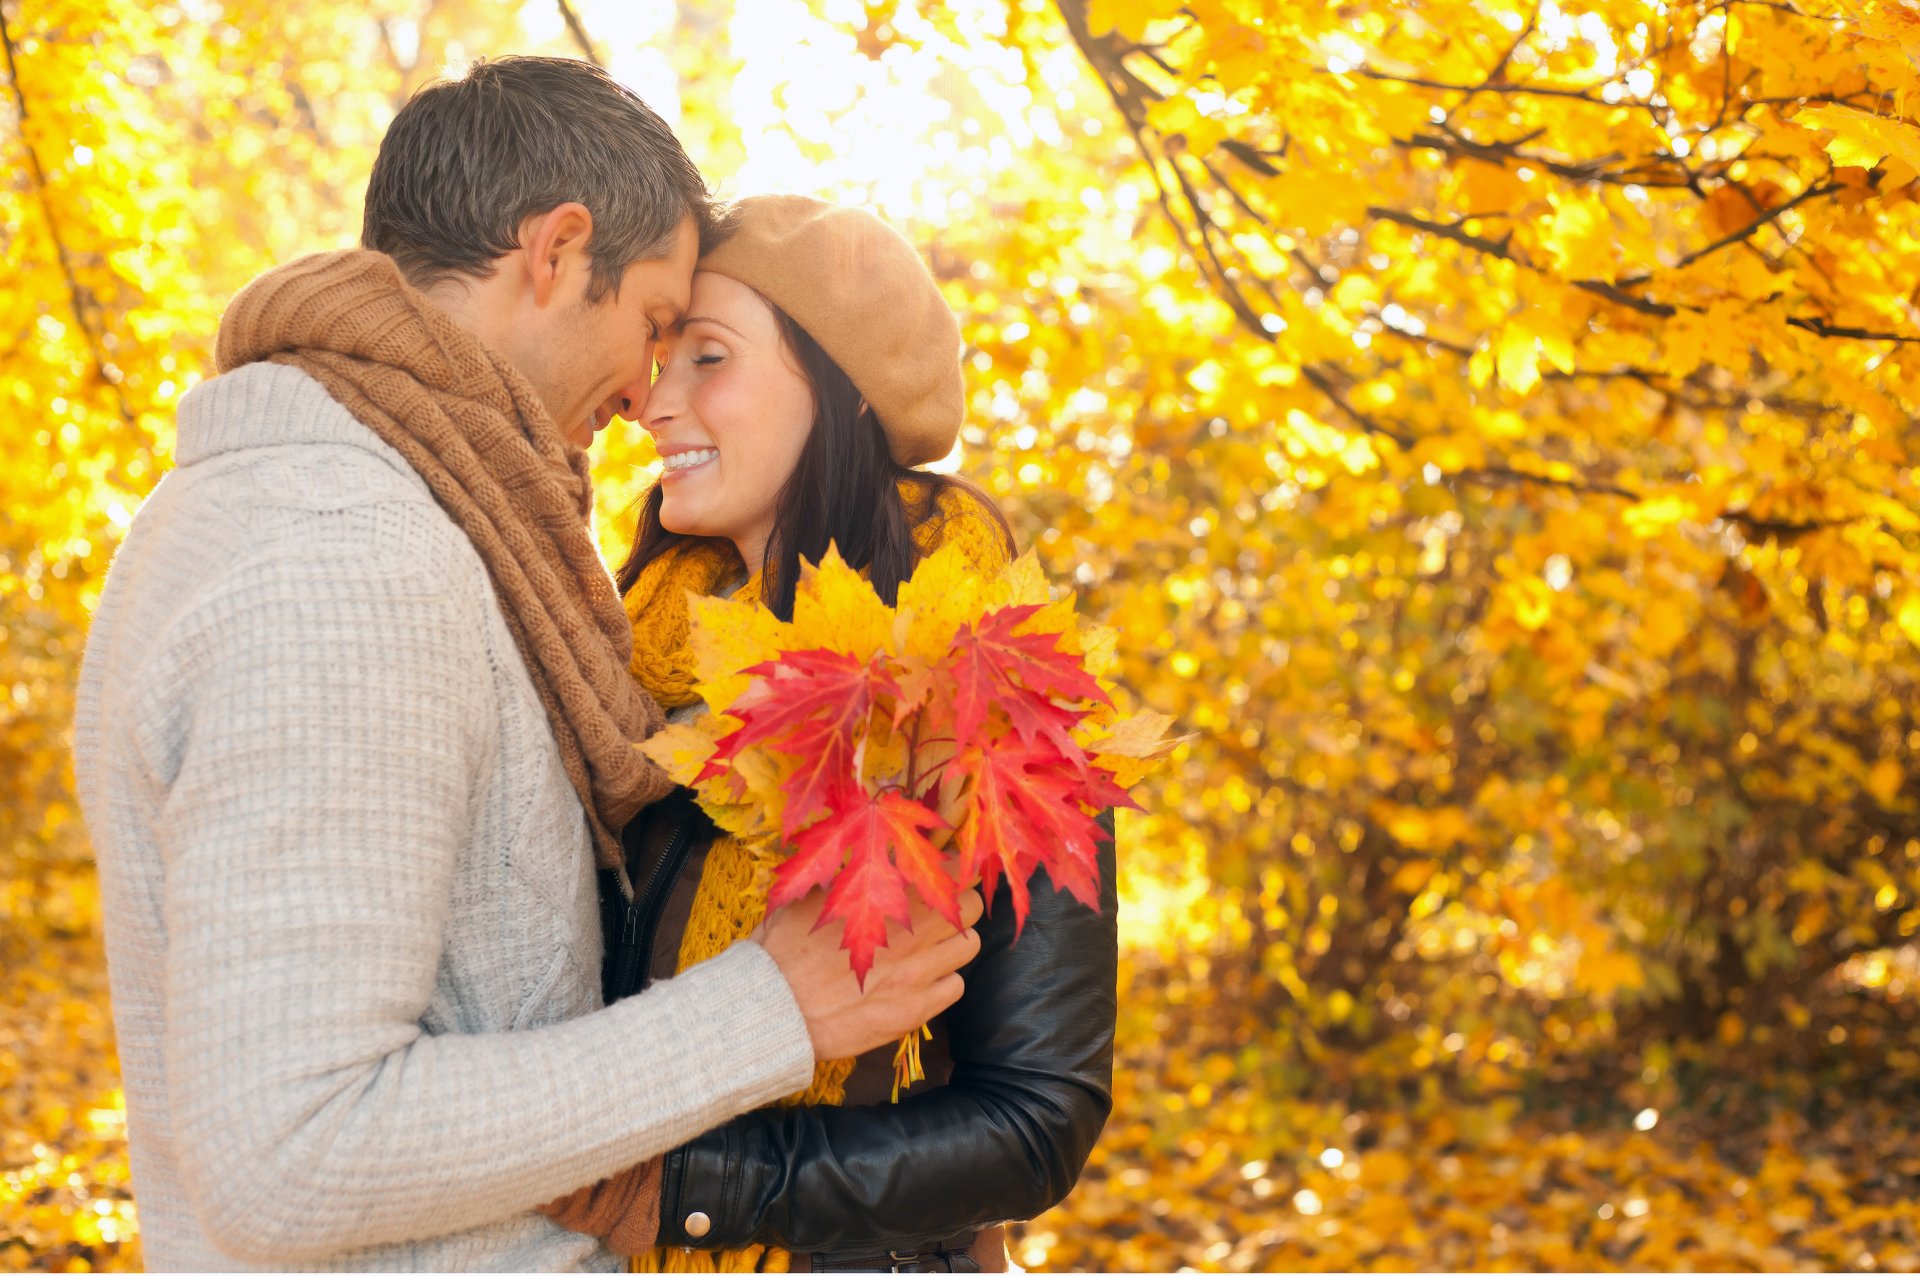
[{"x1": 645, "y1": 271, "x2": 814, "y2": 572}]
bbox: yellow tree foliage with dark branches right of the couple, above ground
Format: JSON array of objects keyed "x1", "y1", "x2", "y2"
[{"x1": 940, "y1": 0, "x2": 1920, "y2": 1076}]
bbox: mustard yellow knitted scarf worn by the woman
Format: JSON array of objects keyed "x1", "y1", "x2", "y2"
[{"x1": 626, "y1": 480, "x2": 1008, "y2": 1272}]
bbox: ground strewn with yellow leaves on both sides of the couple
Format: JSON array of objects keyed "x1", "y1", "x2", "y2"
[{"x1": 0, "y1": 867, "x2": 1920, "y2": 1272}]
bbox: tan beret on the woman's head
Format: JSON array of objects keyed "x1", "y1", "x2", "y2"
[{"x1": 701, "y1": 196, "x2": 966, "y2": 464}]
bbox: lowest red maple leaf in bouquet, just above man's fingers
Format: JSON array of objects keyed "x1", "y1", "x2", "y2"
[{"x1": 766, "y1": 787, "x2": 960, "y2": 984}]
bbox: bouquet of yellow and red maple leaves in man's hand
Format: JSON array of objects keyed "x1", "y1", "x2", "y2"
[{"x1": 641, "y1": 547, "x2": 1173, "y2": 1094}]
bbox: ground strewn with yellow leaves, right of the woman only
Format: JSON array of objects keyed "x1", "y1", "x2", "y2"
[{"x1": 1014, "y1": 954, "x2": 1920, "y2": 1272}]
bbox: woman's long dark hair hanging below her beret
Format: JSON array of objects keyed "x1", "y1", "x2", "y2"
[{"x1": 616, "y1": 307, "x2": 1014, "y2": 620}]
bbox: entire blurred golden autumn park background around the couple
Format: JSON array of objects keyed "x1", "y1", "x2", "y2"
[{"x1": 0, "y1": 0, "x2": 1920, "y2": 1270}]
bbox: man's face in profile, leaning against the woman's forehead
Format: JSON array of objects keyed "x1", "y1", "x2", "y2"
[{"x1": 536, "y1": 217, "x2": 701, "y2": 447}]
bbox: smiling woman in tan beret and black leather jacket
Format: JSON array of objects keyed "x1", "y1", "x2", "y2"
[{"x1": 549, "y1": 196, "x2": 1116, "y2": 1270}]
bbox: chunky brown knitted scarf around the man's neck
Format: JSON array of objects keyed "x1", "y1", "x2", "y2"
[{"x1": 215, "y1": 249, "x2": 672, "y2": 867}]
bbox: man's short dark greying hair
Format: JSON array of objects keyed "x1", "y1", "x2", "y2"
[{"x1": 361, "y1": 56, "x2": 714, "y2": 301}]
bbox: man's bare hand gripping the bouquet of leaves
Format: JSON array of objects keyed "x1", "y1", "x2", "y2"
[{"x1": 755, "y1": 890, "x2": 981, "y2": 1059}]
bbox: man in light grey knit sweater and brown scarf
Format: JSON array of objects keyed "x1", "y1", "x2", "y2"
[{"x1": 75, "y1": 58, "x2": 979, "y2": 1270}]
